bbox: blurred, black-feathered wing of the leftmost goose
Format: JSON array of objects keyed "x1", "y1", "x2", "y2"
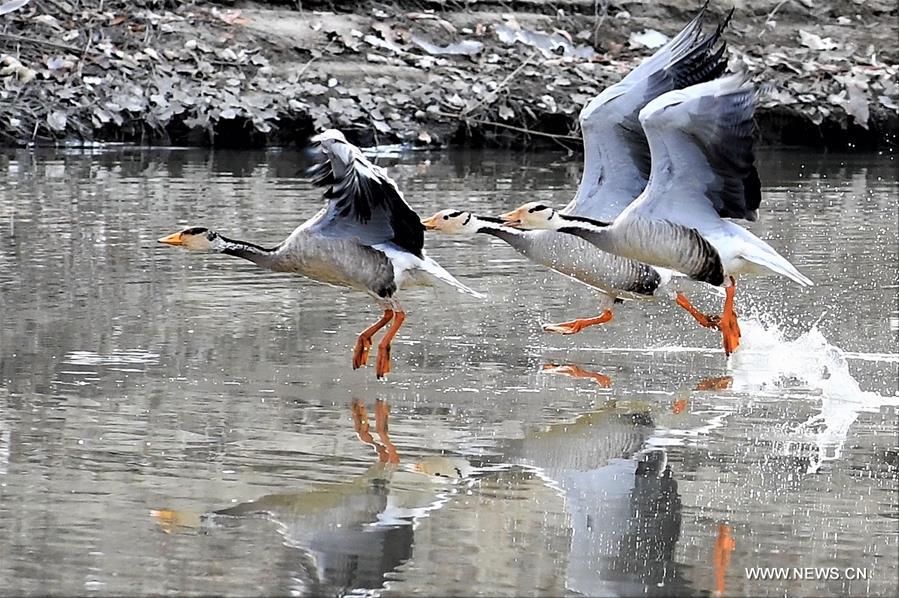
[{"x1": 309, "y1": 129, "x2": 424, "y2": 257}]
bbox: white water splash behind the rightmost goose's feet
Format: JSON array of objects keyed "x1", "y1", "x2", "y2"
[{"x1": 729, "y1": 316, "x2": 899, "y2": 473}]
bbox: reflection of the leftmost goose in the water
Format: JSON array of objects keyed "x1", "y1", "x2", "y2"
[{"x1": 152, "y1": 399, "x2": 472, "y2": 595}]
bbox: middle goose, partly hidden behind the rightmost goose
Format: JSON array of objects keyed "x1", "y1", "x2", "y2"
[{"x1": 422, "y1": 7, "x2": 730, "y2": 334}]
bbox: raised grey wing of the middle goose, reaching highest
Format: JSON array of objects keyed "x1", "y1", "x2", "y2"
[{"x1": 564, "y1": 7, "x2": 733, "y2": 220}]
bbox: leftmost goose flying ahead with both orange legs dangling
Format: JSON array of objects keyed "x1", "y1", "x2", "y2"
[{"x1": 159, "y1": 129, "x2": 483, "y2": 378}]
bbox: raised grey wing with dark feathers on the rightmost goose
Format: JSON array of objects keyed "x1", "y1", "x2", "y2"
[{"x1": 632, "y1": 75, "x2": 762, "y2": 226}]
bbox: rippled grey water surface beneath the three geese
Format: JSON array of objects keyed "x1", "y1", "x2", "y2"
[{"x1": 0, "y1": 148, "x2": 899, "y2": 596}]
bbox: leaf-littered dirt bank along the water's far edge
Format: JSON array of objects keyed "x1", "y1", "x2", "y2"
[{"x1": 0, "y1": 0, "x2": 899, "y2": 148}]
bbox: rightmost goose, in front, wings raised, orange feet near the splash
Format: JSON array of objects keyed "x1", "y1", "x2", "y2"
[{"x1": 503, "y1": 75, "x2": 812, "y2": 355}]
